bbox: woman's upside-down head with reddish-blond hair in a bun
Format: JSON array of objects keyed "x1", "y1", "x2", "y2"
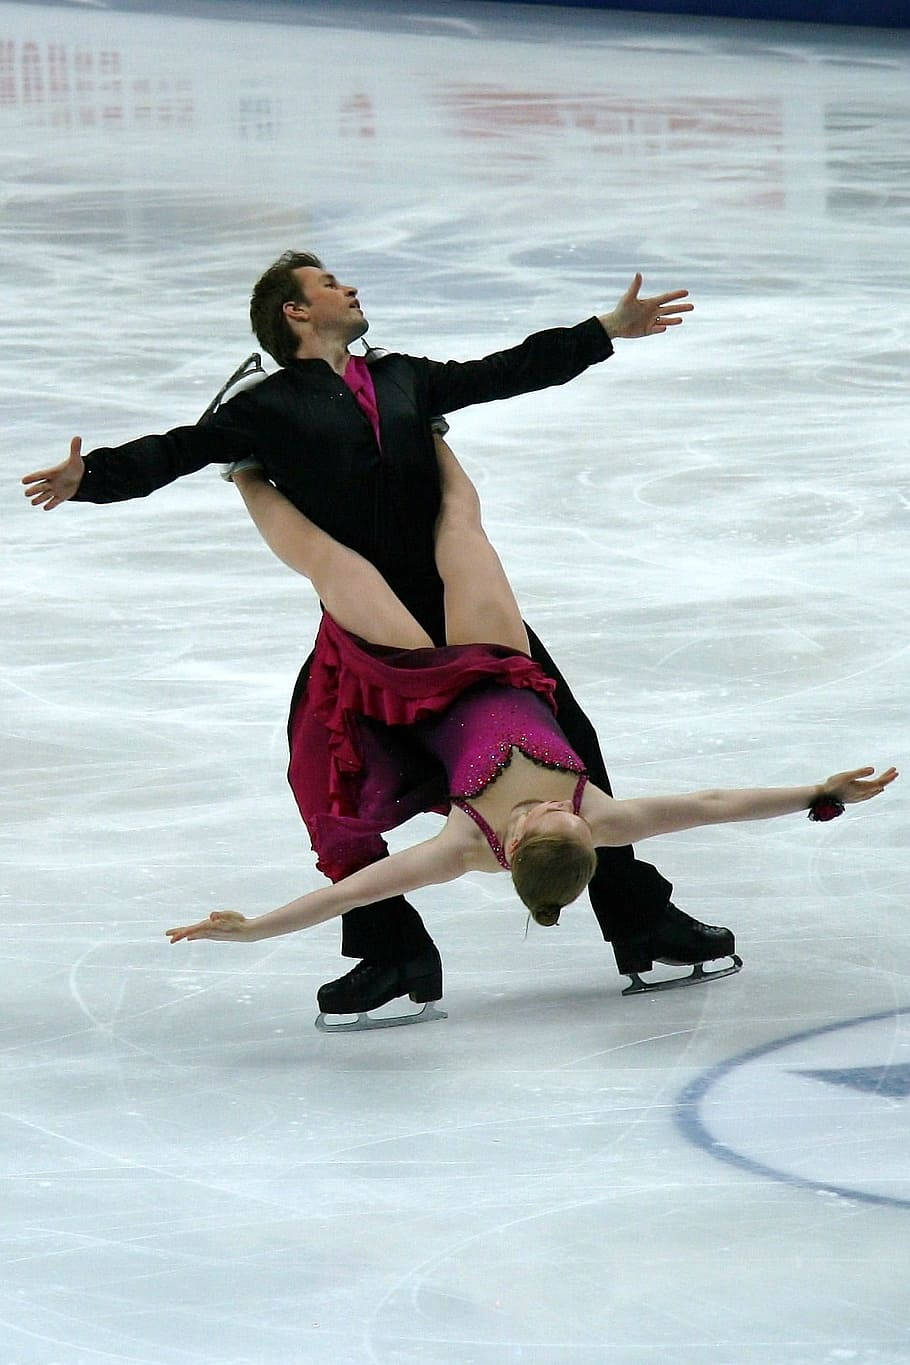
[{"x1": 510, "y1": 819, "x2": 598, "y2": 925}]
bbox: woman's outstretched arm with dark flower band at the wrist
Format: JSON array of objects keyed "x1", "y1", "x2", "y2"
[{"x1": 591, "y1": 767, "x2": 898, "y2": 848}]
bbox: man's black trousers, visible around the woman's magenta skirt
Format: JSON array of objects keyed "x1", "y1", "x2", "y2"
[{"x1": 291, "y1": 628, "x2": 673, "y2": 962}]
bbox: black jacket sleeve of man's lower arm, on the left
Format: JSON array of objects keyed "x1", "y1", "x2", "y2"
[{"x1": 74, "y1": 394, "x2": 263, "y2": 502}]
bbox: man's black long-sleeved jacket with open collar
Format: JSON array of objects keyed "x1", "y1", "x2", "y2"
[{"x1": 76, "y1": 318, "x2": 613, "y2": 637}]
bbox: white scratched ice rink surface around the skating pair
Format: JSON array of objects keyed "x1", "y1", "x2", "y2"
[{"x1": 0, "y1": 0, "x2": 910, "y2": 1365}]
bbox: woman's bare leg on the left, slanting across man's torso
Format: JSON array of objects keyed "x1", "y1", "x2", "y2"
[{"x1": 233, "y1": 470, "x2": 432, "y2": 650}]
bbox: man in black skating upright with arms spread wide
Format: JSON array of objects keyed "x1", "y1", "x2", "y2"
[{"x1": 23, "y1": 253, "x2": 738, "y2": 1014}]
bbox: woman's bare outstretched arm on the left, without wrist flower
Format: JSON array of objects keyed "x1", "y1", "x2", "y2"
[{"x1": 166, "y1": 824, "x2": 469, "y2": 943}]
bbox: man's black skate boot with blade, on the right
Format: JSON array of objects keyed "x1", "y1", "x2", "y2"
[{"x1": 613, "y1": 901, "x2": 742, "y2": 995}]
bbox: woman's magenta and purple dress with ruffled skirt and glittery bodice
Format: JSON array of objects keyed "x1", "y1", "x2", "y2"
[{"x1": 288, "y1": 614, "x2": 584, "y2": 880}]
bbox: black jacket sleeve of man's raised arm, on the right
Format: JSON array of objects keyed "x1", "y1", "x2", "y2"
[{"x1": 419, "y1": 318, "x2": 613, "y2": 412}]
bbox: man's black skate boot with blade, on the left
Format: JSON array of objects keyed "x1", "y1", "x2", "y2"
[{"x1": 317, "y1": 946, "x2": 447, "y2": 1033}]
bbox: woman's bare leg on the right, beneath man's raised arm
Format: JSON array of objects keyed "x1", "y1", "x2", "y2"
[{"x1": 434, "y1": 435, "x2": 531, "y2": 654}]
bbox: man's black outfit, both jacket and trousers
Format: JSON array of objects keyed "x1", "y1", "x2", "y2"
[{"x1": 76, "y1": 318, "x2": 671, "y2": 961}]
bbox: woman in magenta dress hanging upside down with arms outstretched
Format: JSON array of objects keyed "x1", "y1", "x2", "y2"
[{"x1": 166, "y1": 437, "x2": 898, "y2": 955}]
